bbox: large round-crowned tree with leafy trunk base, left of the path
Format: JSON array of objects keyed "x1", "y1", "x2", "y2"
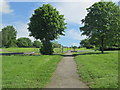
[{"x1": 28, "y1": 4, "x2": 66, "y2": 55}]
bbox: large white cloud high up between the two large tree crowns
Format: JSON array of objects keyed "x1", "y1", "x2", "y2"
[{"x1": 56, "y1": 0, "x2": 99, "y2": 24}]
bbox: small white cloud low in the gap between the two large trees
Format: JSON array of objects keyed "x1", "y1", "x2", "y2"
[{"x1": 65, "y1": 29, "x2": 87, "y2": 40}]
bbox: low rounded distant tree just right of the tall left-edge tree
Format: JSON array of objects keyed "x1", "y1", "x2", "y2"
[{"x1": 17, "y1": 37, "x2": 33, "y2": 47}]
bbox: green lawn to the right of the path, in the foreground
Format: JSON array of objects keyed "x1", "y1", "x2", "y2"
[{"x1": 75, "y1": 51, "x2": 118, "y2": 88}]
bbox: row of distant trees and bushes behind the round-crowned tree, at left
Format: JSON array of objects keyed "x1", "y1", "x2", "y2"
[{"x1": 0, "y1": 26, "x2": 61, "y2": 48}]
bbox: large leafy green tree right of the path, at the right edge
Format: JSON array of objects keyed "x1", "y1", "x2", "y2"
[{"x1": 80, "y1": 2, "x2": 120, "y2": 53}]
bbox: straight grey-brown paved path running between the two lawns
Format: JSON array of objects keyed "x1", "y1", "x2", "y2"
[{"x1": 45, "y1": 52, "x2": 88, "y2": 88}]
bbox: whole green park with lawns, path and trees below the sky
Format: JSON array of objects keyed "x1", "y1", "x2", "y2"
[{"x1": 0, "y1": 1, "x2": 120, "y2": 90}]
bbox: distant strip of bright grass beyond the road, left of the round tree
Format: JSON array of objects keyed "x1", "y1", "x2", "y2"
[{"x1": 3, "y1": 48, "x2": 39, "y2": 53}]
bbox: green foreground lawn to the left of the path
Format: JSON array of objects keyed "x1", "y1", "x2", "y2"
[{"x1": 2, "y1": 55, "x2": 62, "y2": 88}]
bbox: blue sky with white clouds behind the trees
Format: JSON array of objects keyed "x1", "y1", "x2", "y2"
[{"x1": 0, "y1": 0, "x2": 119, "y2": 46}]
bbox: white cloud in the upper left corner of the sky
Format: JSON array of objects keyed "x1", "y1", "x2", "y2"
[{"x1": 0, "y1": 0, "x2": 13, "y2": 14}]
